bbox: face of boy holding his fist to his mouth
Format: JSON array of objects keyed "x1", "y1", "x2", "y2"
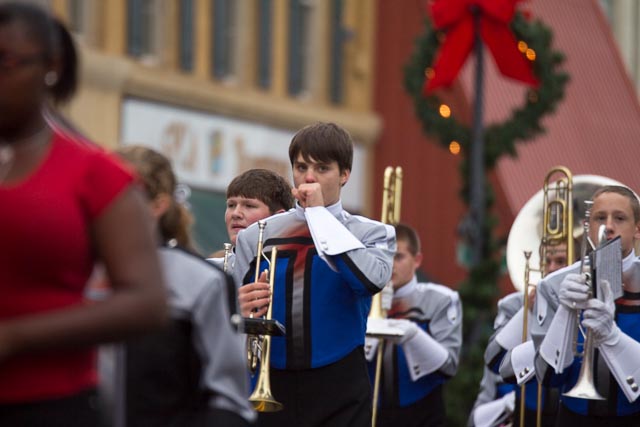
[{"x1": 293, "y1": 154, "x2": 350, "y2": 206}]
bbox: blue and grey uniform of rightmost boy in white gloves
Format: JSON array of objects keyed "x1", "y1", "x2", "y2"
[{"x1": 531, "y1": 252, "x2": 640, "y2": 425}]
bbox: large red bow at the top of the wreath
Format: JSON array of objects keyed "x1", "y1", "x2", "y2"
[{"x1": 424, "y1": 0, "x2": 538, "y2": 93}]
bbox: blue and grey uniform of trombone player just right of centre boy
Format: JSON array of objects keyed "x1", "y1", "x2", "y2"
[{"x1": 367, "y1": 275, "x2": 462, "y2": 426}]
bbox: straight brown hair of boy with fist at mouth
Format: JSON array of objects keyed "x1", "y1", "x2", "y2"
[{"x1": 289, "y1": 122, "x2": 353, "y2": 172}]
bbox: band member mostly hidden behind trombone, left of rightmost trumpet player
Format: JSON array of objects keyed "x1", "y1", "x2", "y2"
[{"x1": 485, "y1": 242, "x2": 568, "y2": 426}]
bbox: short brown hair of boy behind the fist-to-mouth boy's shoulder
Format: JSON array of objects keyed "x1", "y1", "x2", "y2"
[{"x1": 227, "y1": 169, "x2": 293, "y2": 214}]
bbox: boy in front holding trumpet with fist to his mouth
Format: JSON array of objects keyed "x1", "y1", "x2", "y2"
[{"x1": 234, "y1": 123, "x2": 395, "y2": 427}]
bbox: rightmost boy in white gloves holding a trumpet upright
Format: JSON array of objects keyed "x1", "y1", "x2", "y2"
[{"x1": 531, "y1": 186, "x2": 640, "y2": 426}]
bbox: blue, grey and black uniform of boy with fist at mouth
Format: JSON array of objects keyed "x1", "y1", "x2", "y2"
[{"x1": 233, "y1": 202, "x2": 396, "y2": 426}]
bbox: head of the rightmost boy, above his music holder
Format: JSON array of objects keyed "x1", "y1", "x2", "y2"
[{"x1": 589, "y1": 193, "x2": 640, "y2": 256}]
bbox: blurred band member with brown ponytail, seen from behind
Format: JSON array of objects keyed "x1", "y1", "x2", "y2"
[{"x1": 118, "y1": 146, "x2": 256, "y2": 427}]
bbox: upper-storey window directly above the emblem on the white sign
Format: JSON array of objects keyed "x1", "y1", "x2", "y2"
[{"x1": 212, "y1": 0, "x2": 237, "y2": 79}]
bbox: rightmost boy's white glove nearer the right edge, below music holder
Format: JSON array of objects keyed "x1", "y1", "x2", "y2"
[{"x1": 582, "y1": 280, "x2": 620, "y2": 347}]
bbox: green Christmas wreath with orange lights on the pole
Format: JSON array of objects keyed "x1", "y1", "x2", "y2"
[{"x1": 405, "y1": 7, "x2": 568, "y2": 169}]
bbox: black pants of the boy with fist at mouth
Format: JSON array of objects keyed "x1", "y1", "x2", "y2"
[{"x1": 258, "y1": 347, "x2": 371, "y2": 427}]
